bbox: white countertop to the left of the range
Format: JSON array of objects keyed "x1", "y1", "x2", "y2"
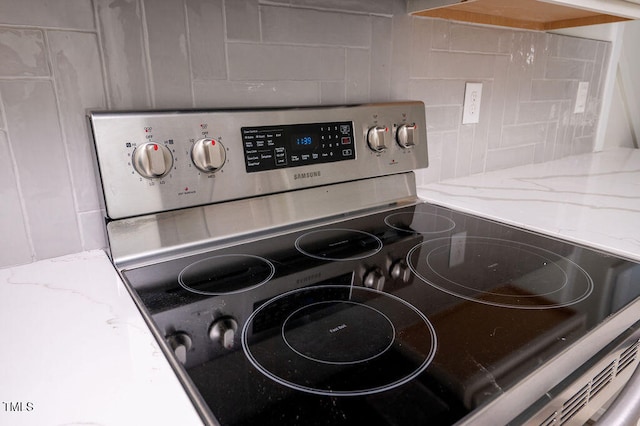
[{"x1": 0, "y1": 251, "x2": 202, "y2": 426}]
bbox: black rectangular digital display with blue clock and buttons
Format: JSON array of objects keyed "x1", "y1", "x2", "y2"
[{"x1": 242, "y1": 121, "x2": 356, "y2": 173}]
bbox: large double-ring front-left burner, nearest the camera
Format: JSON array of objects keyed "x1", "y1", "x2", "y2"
[{"x1": 242, "y1": 285, "x2": 436, "y2": 396}]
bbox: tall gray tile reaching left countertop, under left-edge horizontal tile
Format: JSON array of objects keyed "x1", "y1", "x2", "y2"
[{"x1": 0, "y1": 80, "x2": 82, "y2": 259}]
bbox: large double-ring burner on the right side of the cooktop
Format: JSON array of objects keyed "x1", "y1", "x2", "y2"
[{"x1": 407, "y1": 236, "x2": 593, "y2": 309}]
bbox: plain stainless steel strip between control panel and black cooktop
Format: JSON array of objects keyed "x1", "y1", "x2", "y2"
[{"x1": 107, "y1": 172, "x2": 417, "y2": 269}]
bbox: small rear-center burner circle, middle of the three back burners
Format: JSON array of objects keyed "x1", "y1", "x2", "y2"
[{"x1": 295, "y1": 228, "x2": 382, "y2": 260}]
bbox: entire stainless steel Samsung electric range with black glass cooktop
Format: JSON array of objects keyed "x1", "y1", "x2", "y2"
[{"x1": 89, "y1": 102, "x2": 640, "y2": 425}]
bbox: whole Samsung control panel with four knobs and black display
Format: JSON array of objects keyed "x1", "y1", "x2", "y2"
[{"x1": 89, "y1": 101, "x2": 428, "y2": 219}]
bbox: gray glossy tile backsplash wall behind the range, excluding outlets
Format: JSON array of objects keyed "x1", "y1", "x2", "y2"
[{"x1": 0, "y1": 0, "x2": 610, "y2": 267}]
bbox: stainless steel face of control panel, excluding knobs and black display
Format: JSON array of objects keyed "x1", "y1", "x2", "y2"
[{"x1": 89, "y1": 102, "x2": 428, "y2": 219}]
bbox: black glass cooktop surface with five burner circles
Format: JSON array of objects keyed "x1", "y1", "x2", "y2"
[{"x1": 123, "y1": 203, "x2": 638, "y2": 425}]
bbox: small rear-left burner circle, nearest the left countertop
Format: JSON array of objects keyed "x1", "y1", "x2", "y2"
[{"x1": 178, "y1": 254, "x2": 276, "y2": 296}]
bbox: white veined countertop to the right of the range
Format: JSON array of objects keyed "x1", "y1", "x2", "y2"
[{"x1": 418, "y1": 148, "x2": 640, "y2": 261}]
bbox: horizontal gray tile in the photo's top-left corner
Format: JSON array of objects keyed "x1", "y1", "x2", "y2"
[{"x1": 0, "y1": 0, "x2": 95, "y2": 30}]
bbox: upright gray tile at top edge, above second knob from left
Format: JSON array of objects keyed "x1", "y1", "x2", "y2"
[{"x1": 186, "y1": 0, "x2": 227, "y2": 79}]
